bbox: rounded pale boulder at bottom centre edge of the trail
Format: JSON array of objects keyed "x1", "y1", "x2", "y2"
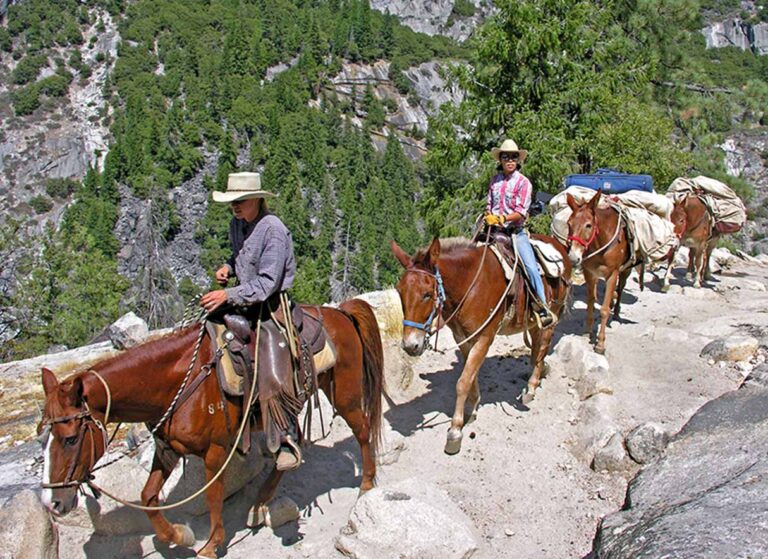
[{"x1": 336, "y1": 478, "x2": 478, "y2": 559}]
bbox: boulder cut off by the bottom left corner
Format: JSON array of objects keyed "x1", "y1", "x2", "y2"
[{"x1": 0, "y1": 490, "x2": 59, "y2": 559}]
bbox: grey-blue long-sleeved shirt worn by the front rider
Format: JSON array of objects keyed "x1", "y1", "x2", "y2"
[{"x1": 226, "y1": 213, "x2": 296, "y2": 305}]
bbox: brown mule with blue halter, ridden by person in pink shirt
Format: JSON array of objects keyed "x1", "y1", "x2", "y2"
[{"x1": 391, "y1": 235, "x2": 570, "y2": 454}]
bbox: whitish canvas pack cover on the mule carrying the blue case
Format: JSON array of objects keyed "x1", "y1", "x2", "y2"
[{"x1": 549, "y1": 186, "x2": 678, "y2": 261}]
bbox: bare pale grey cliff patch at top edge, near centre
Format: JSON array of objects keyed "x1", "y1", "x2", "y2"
[{"x1": 371, "y1": 0, "x2": 493, "y2": 41}]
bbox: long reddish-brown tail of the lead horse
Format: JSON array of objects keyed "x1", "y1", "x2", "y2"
[{"x1": 339, "y1": 299, "x2": 385, "y2": 456}]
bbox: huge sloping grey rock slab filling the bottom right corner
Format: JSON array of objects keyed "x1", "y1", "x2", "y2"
[{"x1": 593, "y1": 386, "x2": 768, "y2": 559}]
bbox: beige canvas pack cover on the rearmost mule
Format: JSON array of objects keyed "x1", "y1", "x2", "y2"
[{"x1": 667, "y1": 175, "x2": 747, "y2": 233}]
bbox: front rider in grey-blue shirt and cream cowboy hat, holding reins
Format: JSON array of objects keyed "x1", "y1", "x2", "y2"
[{"x1": 200, "y1": 173, "x2": 301, "y2": 470}]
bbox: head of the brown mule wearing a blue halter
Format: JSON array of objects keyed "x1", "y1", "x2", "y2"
[{"x1": 390, "y1": 237, "x2": 445, "y2": 356}]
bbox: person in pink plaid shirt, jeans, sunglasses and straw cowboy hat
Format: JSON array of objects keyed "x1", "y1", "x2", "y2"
[{"x1": 485, "y1": 139, "x2": 557, "y2": 326}]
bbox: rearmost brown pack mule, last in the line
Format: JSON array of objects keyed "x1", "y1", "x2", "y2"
[{"x1": 661, "y1": 194, "x2": 720, "y2": 292}]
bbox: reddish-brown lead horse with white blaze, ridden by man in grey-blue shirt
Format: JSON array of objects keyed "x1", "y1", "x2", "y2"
[{"x1": 38, "y1": 300, "x2": 384, "y2": 557}]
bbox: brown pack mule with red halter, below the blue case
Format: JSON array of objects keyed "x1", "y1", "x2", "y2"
[{"x1": 567, "y1": 191, "x2": 642, "y2": 354}]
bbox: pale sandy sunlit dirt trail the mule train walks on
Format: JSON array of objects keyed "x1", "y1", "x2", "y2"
[{"x1": 10, "y1": 262, "x2": 768, "y2": 559}]
